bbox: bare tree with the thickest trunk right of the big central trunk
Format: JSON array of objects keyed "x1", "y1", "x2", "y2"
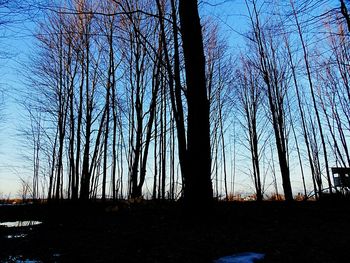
[{"x1": 247, "y1": 1, "x2": 293, "y2": 201}]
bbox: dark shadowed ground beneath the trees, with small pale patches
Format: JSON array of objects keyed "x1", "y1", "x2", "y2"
[{"x1": 0, "y1": 202, "x2": 350, "y2": 263}]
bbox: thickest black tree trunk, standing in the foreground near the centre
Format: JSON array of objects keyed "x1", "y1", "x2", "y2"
[{"x1": 179, "y1": 0, "x2": 213, "y2": 208}]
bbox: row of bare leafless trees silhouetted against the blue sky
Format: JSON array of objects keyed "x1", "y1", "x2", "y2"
[{"x1": 17, "y1": 0, "x2": 350, "y2": 206}]
